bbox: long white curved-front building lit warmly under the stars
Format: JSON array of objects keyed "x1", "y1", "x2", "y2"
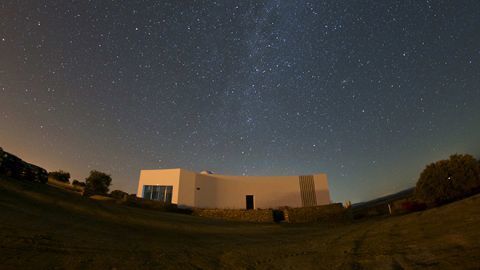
[{"x1": 137, "y1": 169, "x2": 330, "y2": 209}]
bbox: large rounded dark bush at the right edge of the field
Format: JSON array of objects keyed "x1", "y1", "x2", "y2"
[{"x1": 415, "y1": 155, "x2": 480, "y2": 205}]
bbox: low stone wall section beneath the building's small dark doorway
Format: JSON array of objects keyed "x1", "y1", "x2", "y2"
[{"x1": 192, "y1": 208, "x2": 274, "y2": 223}]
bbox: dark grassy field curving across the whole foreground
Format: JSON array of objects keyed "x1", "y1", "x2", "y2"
[{"x1": 0, "y1": 177, "x2": 480, "y2": 269}]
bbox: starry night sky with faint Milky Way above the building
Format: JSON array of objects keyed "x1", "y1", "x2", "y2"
[{"x1": 0, "y1": 0, "x2": 480, "y2": 202}]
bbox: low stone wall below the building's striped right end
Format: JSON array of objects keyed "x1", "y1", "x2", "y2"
[{"x1": 282, "y1": 203, "x2": 352, "y2": 223}]
